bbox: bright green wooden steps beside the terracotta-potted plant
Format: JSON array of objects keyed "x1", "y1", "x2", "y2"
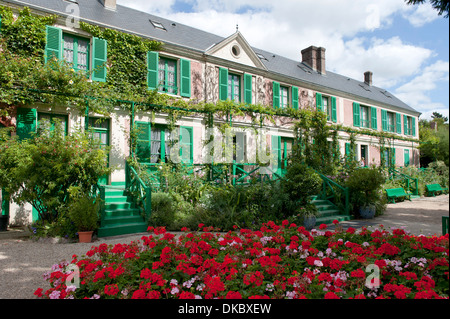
[{"x1": 98, "y1": 182, "x2": 147, "y2": 237}]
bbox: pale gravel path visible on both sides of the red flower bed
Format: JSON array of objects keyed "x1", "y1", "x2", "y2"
[{"x1": 0, "y1": 195, "x2": 449, "y2": 299}]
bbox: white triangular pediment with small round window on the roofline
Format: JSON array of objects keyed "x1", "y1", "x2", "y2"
[{"x1": 205, "y1": 31, "x2": 267, "y2": 70}]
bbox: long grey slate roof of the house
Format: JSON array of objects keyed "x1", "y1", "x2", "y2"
[{"x1": 4, "y1": 0, "x2": 420, "y2": 114}]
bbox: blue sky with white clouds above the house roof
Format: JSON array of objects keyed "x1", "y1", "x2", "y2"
[{"x1": 117, "y1": 0, "x2": 449, "y2": 119}]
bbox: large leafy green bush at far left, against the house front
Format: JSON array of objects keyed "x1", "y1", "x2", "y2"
[{"x1": 0, "y1": 123, "x2": 111, "y2": 222}]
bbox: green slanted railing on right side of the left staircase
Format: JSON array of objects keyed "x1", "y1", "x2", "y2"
[{"x1": 125, "y1": 163, "x2": 152, "y2": 219}]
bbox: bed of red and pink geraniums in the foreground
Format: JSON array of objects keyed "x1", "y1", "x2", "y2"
[{"x1": 35, "y1": 221, "x2": 449, "y2": 299}]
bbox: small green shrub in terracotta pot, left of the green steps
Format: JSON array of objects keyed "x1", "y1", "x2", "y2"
[{"x1": 67, "y1": 187, "x2": 100, "y2": 243}]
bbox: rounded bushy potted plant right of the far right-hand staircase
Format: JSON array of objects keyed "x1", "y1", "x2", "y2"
[{"x1": 346, "y1": 167, "x2": 385, "y2": 219}]
